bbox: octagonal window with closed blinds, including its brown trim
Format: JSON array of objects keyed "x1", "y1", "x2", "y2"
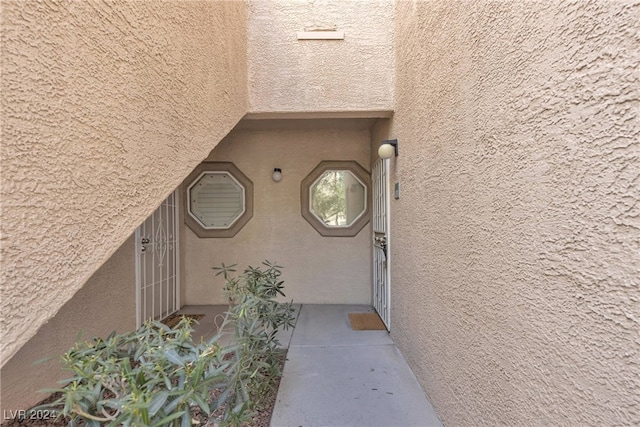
[{"x1": 185, "y1": 162, "x2": 253, "y2": 237}]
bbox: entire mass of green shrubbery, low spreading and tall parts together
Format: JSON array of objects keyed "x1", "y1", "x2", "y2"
[{"x1": 34, "y1": 262, "x2": 294, "y2": 427}]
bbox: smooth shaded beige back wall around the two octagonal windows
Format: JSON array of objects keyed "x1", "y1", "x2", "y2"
[{"x1": 181, "y1": 120, "x2": 371, "y2": 304}]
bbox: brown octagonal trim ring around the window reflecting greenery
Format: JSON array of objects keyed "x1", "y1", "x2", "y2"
[{"x1": 300, "y1": 160, "x2": 371, "y2": 237}]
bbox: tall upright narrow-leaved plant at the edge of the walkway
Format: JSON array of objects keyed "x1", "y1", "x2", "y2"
[{"x1": 214, "y1": 261, "x2": 295, "y2": 422}]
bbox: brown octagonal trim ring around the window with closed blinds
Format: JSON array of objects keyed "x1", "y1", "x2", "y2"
[{"x1": 183, "y1": 162, "x2": 253, "y2": 238}]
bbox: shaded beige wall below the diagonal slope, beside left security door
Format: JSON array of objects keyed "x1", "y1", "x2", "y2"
[{"x1": 0, "y1": 237, "x2": 136, "y2": 414}]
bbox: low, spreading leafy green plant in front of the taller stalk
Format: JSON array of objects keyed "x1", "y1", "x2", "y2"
[{"x1": 33, "y1": 318, "x2": 238, "y2": 426}]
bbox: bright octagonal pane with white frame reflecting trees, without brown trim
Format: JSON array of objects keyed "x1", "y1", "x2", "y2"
[{"x1": 309, "y1": 169, "x2": 367, "y2": 227}]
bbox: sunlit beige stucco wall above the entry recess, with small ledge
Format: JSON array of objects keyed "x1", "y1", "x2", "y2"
[{"x1": 248, "y1": 0, "x2": 394, "y2": 112}]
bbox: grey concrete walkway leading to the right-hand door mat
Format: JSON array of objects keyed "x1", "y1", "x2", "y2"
[{"x1": 271, "y1": 305, "x2": 442, "y2": 427}]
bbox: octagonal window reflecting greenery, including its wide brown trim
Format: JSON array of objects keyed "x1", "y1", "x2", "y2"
[{"x1": 300, "y1": 161, "x2": 370, "y2": 237}]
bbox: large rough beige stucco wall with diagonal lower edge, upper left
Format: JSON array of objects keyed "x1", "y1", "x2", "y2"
[{"x1": 0, "y1": 0, "x2": 248, "y2": 364}]
